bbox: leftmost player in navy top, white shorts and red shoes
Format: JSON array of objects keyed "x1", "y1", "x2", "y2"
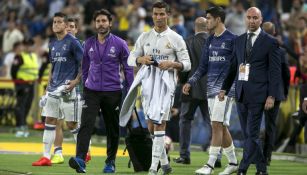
[{"x1": 32, "y1": 12, "x2": 83, "y2": 166}]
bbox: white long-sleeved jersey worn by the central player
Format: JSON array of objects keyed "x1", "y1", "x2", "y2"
[{"x1": 128, "y1": 28, "x2": 191, "y2": 71}]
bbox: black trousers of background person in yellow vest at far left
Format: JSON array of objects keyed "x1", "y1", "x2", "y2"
[{"x1": 15, "y1": 83, "x2": 34, "y2": 127}]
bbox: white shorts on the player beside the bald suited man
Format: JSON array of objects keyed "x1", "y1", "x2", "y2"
[{"x1": 208, "y1": 96, "x2": 234, "y2": 126}]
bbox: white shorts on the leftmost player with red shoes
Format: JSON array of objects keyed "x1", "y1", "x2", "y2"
[{"x1": 42, "y1": 94, "x2": 82, "y2": 122}]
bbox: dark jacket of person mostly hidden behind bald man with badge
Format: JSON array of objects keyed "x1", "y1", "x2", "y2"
[{"x1": 276, "y1": 47, "x2": 290, "y2": 101}]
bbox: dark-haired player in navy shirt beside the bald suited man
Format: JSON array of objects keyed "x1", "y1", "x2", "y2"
[{"x1": 182, "y1": 7, "x2": 238, "y2": 174}]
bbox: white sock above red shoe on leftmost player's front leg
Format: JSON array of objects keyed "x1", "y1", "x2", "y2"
[{"x1": 43, "y1": 124, "x2": 56, "y2": 159}]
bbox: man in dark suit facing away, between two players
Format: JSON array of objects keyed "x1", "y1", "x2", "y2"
[{"x1": 174, "y1": 17, "x2": 210, "y2": 164}]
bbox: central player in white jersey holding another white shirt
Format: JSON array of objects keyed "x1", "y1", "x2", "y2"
[{"x1": 120, "y1": 2, "x2": 191, "y2": 174}]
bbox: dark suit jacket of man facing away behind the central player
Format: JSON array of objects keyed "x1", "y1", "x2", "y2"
[{"x1": 179, "y1": 33, "x2": 209, "y2": 101}]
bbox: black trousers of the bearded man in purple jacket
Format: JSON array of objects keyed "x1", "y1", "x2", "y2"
[{"x1": 76, "y1": 88, "x2": 122, "y2": 163}]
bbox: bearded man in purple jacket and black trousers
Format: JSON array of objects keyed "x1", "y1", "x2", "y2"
[{"x1": 69, "y1": 9, "x2": 133, "y2": 173}]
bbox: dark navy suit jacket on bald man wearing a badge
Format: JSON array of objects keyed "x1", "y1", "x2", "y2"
[{"x1": 222, "y1": 30, "x2": 281, "y2": 103}]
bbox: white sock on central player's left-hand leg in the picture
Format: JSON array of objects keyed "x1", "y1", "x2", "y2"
[{"x1": 150, "y1": 131, "x2": 167, "y2": 171}]
